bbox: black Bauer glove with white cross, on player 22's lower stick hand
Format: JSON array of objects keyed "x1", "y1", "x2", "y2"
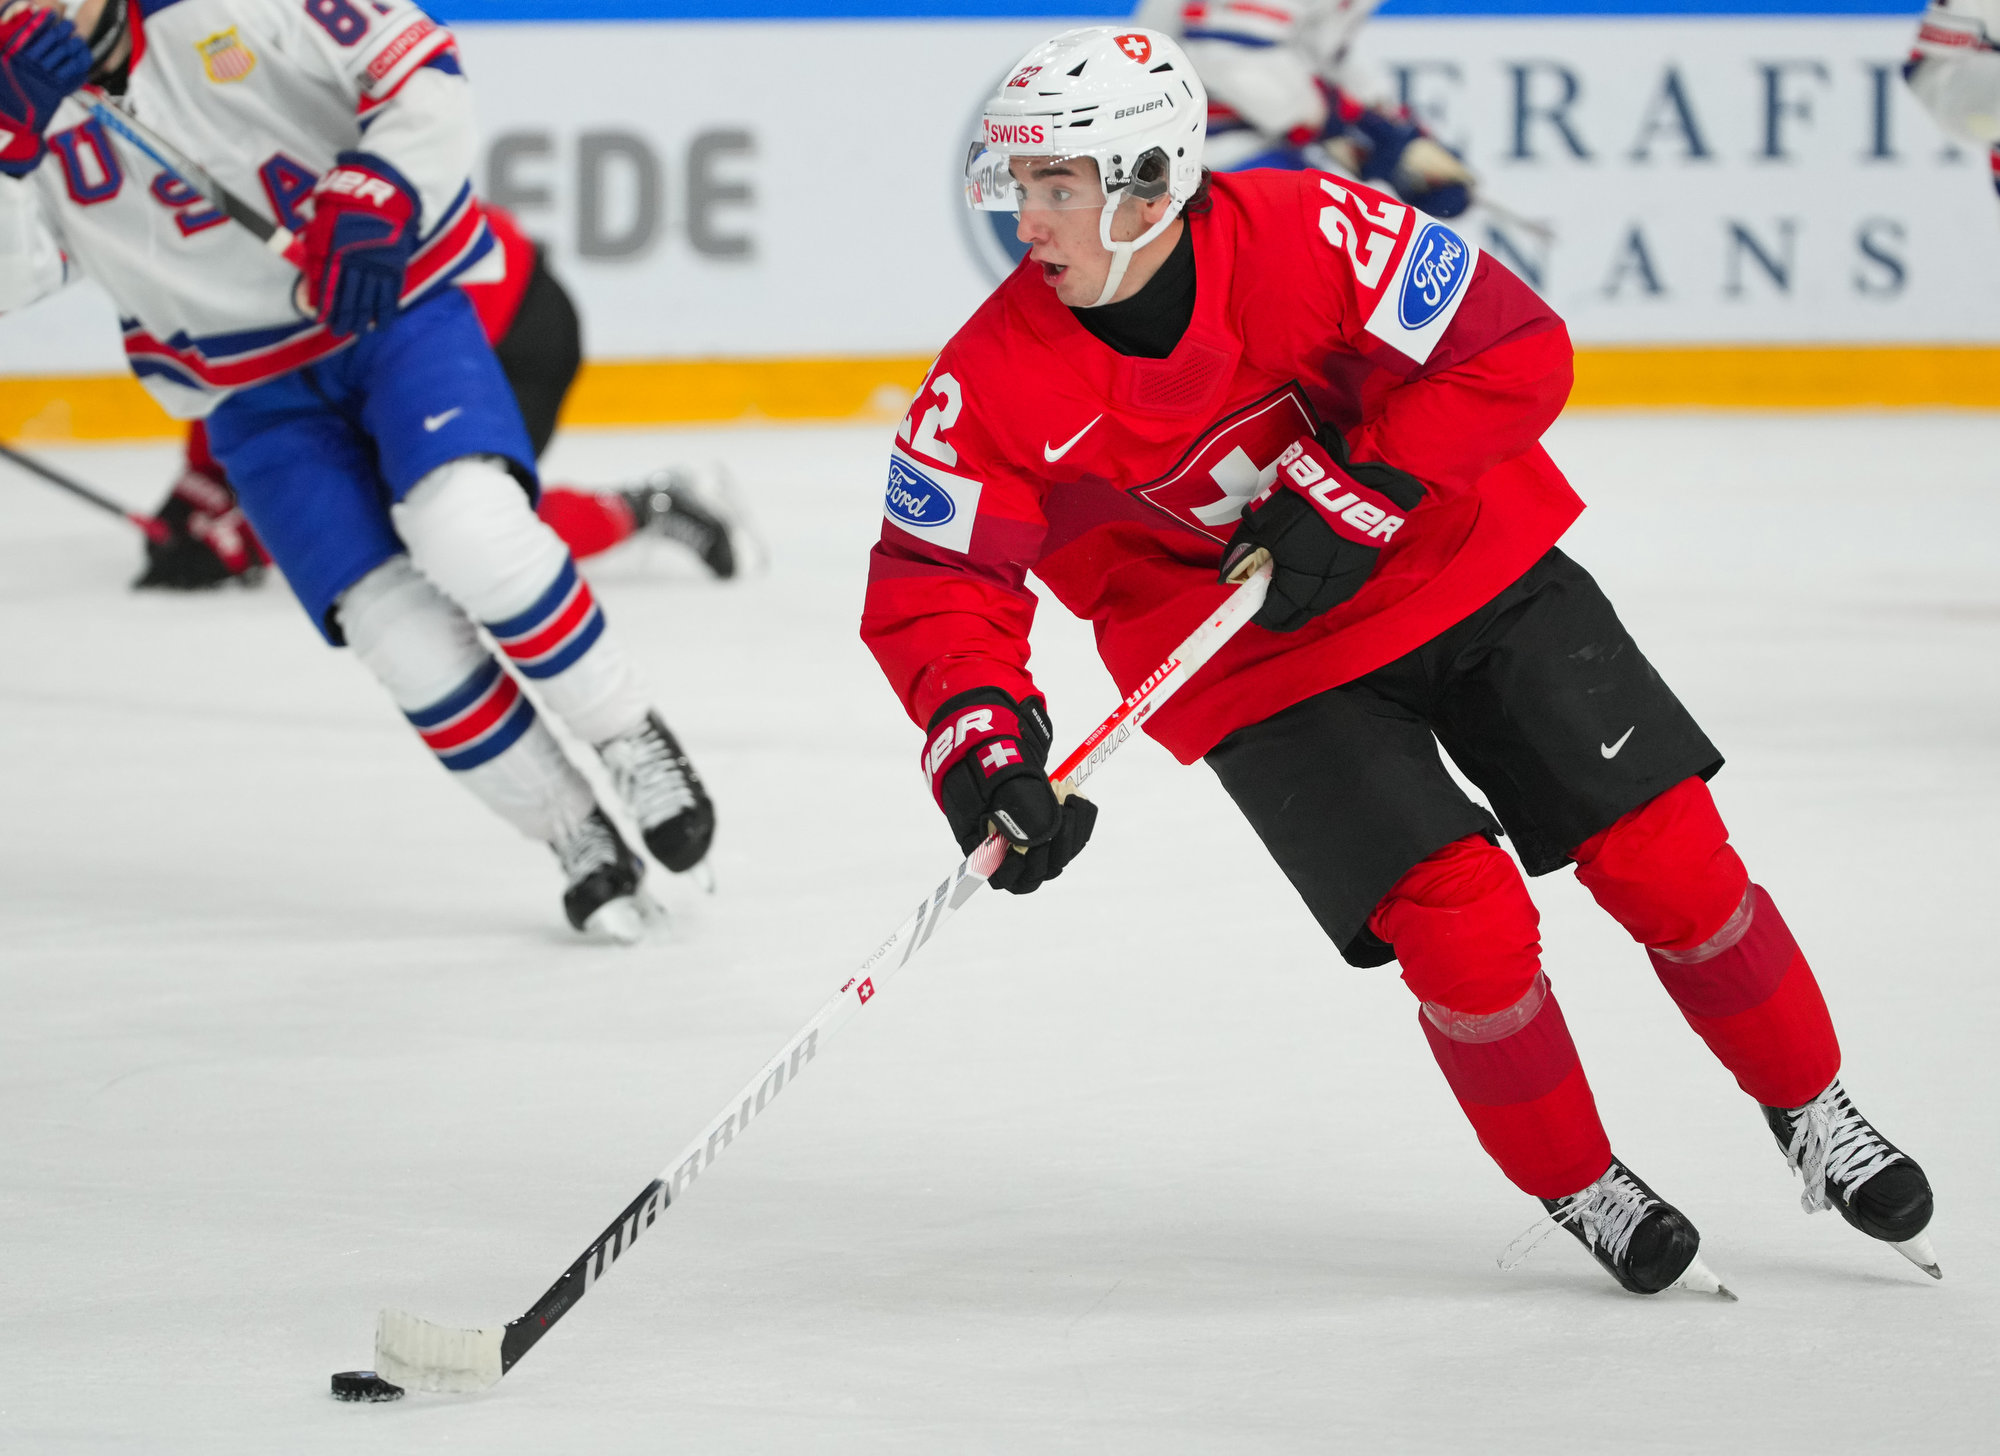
[{"x1": 924, "y1": 688, "x2": 1098, "y2": 894}]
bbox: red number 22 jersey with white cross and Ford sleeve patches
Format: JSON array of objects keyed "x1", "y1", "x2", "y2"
[{"x1": 862, "y1": 172, "x2": 1584, "y2": 764}]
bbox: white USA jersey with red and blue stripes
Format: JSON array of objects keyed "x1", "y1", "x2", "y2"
[{"x1": 0, "y1": 0, "x2": 492, "y2": 416}]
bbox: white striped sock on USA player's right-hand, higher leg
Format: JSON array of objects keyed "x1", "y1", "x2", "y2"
[{"x1": 392, "y1": 456, "x2": 648, "y2": 744}]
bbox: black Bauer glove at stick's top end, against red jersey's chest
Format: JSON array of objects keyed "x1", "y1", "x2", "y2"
[{"x1": 1218, "y1": 426, "x2": 1424, "y2": 632}]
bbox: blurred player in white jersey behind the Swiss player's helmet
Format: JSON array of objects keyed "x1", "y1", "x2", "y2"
[{"x1": 1144, "y1": 0, "x2": 1474, "y2": 218}]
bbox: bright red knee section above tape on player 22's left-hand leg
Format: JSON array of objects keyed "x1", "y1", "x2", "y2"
[{"x1": 1368, "y1": 834, "x2": 1542, "y2": 1016}]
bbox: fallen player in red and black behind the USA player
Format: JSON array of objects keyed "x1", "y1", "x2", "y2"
[{"x1": 134, "y1": 204, "x2": 736, "y2": 592}]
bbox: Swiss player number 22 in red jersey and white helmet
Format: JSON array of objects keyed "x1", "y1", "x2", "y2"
[{"x1": 862, "y1": 28, "x2": 1936, "y2": 1294}]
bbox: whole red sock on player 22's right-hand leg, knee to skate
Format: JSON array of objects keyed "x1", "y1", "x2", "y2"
[{"x1": 1574, "y1": 778, "x2": 1840, "y2": 1108}]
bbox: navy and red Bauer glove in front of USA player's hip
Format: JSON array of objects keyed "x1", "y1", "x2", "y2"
[{"x1": 284, "y1": 152, "x2": 422, "y2": 336}]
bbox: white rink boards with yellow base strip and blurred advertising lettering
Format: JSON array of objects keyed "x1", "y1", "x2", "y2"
[{"x1": 0, "y1": 0, "x2": 2000, "y2": 438}]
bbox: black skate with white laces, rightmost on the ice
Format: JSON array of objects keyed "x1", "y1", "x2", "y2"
[{"x1": 1764, "y1": 1078, "x2": 1944, "y2": 1280}]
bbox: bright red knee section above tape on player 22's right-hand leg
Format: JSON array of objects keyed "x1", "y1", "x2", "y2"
[{"x1": 1570, "y1": 778, "x2": 1750, "y2": 950}]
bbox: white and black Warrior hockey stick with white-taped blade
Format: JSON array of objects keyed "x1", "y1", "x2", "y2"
[{"x1": 368, "y1": 552, "x2": 1270, "y2": 1398}]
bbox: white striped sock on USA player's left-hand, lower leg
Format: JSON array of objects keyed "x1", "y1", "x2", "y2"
[{"x1": 340, "y1": 556, "x2": 596, "y2": 844}]
